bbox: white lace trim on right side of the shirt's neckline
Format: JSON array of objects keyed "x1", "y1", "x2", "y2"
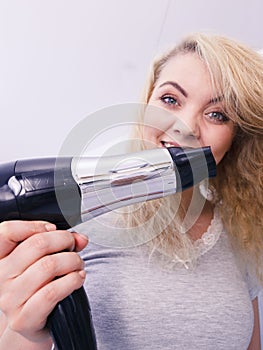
[{"x1": 194, "y1": 207, "x2": 224, "y2": 257}]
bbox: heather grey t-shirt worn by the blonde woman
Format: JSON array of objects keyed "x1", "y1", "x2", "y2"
[{"x1": 81, "y1": 223, "x2": 259, "y2": 350}]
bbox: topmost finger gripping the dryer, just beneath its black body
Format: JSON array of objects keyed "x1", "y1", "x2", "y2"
[{"x1": 0, "y1": 220, "x2": 56, "y2": 259}]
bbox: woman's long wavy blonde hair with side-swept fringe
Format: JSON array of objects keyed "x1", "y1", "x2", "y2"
[{"x1": 126, "y1": 34, "x2": 263, "y2": 275}]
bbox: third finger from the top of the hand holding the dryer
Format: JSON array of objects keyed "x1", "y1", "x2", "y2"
[{"x1": 9, "y1": 252, "x2": 84, "y2": 308}]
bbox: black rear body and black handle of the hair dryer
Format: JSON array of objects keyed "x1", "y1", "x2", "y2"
[{"x1": 0, "y1": 158, "x2": 97, "y2": 350}]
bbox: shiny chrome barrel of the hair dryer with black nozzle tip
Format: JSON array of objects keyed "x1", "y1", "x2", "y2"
[{"x1": 72, "y1": 147, "x2": 215, "y2": 222}]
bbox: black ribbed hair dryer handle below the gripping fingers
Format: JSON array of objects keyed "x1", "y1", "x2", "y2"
[{"x1": 47, "y1": 287, "x2": 97, "y2": 350}]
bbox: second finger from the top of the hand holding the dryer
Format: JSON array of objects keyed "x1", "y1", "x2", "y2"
[{"x1": 0, "y1": 231, "x2": 75, "y2": 281}]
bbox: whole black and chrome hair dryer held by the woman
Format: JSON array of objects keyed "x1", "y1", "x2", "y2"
[{"x1": 0, "y1": 147, "x2": 216, "y2": 350}]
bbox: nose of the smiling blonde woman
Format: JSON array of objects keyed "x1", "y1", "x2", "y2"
[{"x1": 172, "y1": 113, "x2": 200, "y2": 138}]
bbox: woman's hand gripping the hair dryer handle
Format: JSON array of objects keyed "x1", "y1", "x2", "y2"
[{"x1": 0, "y1": 221, "x2": 88, "y2": 342}]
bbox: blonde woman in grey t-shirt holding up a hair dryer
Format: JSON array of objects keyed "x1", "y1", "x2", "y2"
[{"x1": 0, "y1": 35, "x2": 263, "y2": 350}]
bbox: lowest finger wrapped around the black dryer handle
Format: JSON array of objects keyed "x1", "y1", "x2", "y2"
[{"x1": 8, "y1": 270, "x2": 85, "y2": 339}]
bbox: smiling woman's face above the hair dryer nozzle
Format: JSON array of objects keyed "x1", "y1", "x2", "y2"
[{"x1": 143, "y1": 53, "x2": 237, "y2": 164}]
